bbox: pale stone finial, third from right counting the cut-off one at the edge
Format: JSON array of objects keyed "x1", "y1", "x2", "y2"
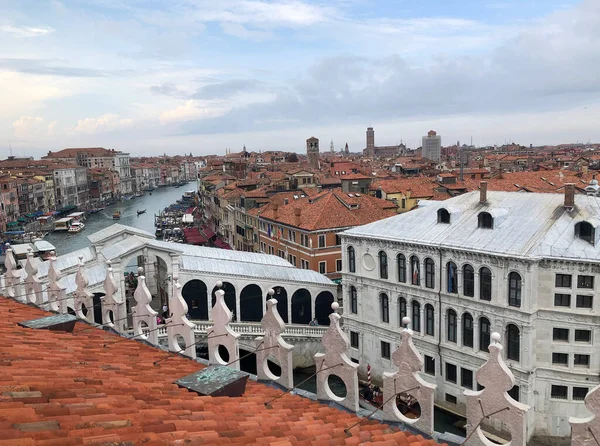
[{"x1": 383, "y1": 317, "x2": 436, "y2": 435}]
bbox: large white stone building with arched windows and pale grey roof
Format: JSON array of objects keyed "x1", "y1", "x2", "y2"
[{"x1": 342, "y1": 183, "x2": 600, "y2": 437}]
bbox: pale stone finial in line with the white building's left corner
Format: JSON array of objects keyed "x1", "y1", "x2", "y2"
[{"x1": 314, "y1": 302, "x2": 358, "y2": 412}]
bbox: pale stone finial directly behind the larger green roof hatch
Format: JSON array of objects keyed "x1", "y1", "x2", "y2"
[{"x1": 208, "y1": 290, "x2": 240, "y2": 370}]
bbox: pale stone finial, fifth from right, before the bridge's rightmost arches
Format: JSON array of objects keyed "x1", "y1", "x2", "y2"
[{"x1": 256, "y1": 298, "x2": 294, "y2": 389}]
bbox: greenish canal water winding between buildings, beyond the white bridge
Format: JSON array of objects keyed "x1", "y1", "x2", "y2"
[{"x1": 45, "y1": 181, "x2": 198, "y2": 256}]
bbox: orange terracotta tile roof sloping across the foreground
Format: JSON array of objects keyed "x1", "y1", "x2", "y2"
[{"x1": 0, "y1": 298, "x2": 435, "y2": 446}]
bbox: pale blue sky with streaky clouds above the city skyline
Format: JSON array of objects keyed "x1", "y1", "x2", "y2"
[{"x1": 0, "y1": 0, "x2": 600, "y2": 158}]
